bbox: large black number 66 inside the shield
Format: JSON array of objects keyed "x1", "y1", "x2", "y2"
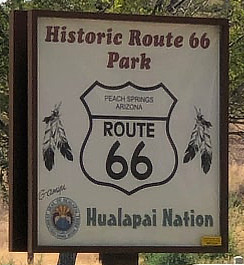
[{"x1": 106, "y1": 141, "x2": 152, "y2": 180}]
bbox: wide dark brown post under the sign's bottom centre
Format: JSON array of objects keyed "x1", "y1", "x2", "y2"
[{"x1": 99, "y1": 253, "x2": 138, "y2": 265}]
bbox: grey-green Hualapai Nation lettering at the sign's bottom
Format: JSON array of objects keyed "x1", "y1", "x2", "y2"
[{"x1": 86, "y1": 208, "x2": 214, "y2": 229}]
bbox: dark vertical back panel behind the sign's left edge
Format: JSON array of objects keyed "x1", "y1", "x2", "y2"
[{"x1": 9, "y1": 11, "x2": 28, "y2": 252}]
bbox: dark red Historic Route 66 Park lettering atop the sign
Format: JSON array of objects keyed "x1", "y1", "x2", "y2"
[{"x1": 45, "y1": 26, "x2": 210, "y2": 70}]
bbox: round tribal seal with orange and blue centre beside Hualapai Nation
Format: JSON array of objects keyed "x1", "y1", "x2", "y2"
[{"x1": 45, "y1": 197, "x2": 80, "y2": 239}]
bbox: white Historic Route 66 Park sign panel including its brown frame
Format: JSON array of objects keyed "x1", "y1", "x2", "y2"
[{"x1": 25, "y1": 11, "x2": 228, "y2": 252}]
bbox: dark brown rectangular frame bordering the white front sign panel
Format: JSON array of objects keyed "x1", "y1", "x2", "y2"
[{"x1": 24, "y1": 10, "x2": 228, "y2": 253}]
